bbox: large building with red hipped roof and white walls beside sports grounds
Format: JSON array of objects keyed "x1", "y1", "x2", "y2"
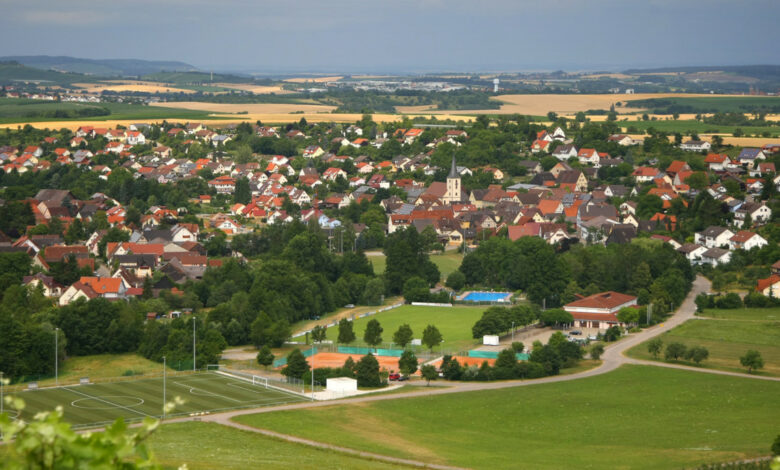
[{"x1": 563, "y1": 291, "x2": 637, "y2": 330}]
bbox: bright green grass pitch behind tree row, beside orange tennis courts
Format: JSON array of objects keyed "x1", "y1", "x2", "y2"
[{"x1": 327, "y1": 305, "x2": 485, "y2": 351}]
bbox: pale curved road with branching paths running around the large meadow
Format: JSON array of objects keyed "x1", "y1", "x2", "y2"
[{"x1": 183, "y1": 276, "x2": 780, "y2": 469}]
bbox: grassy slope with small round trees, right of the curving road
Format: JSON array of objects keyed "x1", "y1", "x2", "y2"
[{"x1": 628, "y1": 318, "x2": 780, "y2": 376}]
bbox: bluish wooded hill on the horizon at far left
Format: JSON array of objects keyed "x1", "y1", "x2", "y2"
[{"x1": 0, "y1": 55, "x2": 198, "y2": 77}]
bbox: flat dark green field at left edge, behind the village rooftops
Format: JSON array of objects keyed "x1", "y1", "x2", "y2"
[{"x1": 0, "y1": 98, "x2": 225, "y2": 123}]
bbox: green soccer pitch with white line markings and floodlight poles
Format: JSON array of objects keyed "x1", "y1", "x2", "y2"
[{"x1": 5, "y1": 372, "x2": 306, "y2": 427}]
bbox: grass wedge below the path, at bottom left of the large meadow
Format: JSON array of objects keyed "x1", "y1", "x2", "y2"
[{"x1": 149, "y1": 422, "x2": 406, "y2": 470}]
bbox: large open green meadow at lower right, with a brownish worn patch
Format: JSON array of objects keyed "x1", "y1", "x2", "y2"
[{"x1": 236, "y1": 366, "x2": 780, "y2": 469}]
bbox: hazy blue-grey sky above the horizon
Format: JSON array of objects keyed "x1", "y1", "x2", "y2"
[{"x1": 0, "y1": 0, "x2": 780, "y2": 74}]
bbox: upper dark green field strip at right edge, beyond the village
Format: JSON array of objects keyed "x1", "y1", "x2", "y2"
[{"x1": 627, "y1": 96, "x2": 780, "y2": 114}]
